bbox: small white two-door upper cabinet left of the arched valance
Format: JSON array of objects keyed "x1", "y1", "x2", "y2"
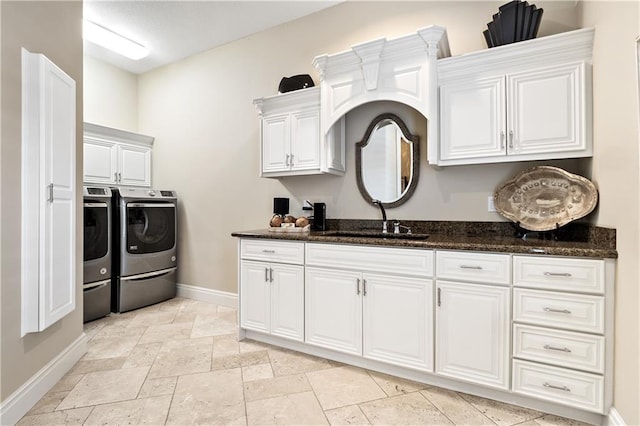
[{"x1": 254, "y1": 87, "x2": 345, "y2": 177}]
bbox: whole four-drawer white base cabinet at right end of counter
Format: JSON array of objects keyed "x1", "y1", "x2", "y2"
[{"x1": 513, "y1": 256, "x2": 613, "y2": 413}]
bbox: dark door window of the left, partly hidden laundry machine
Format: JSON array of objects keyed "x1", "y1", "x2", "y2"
[{"x1": 84, "y1": 202, "x2": 109, "y2": 262}]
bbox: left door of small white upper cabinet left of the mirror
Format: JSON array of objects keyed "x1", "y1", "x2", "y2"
[{"x1": 262, "y1": 114, "x2": 291, "y2": 173}]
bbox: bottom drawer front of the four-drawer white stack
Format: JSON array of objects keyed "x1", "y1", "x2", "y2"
[{"x1": 513, "y1": 360, "x2": 604, "y2": 413}]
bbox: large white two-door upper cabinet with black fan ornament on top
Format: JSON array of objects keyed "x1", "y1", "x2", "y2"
[{"x1": 438, "y1": 29, "x2": 594, "y2": 165}]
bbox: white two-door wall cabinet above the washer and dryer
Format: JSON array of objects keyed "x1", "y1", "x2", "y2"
[{"x1": 84, "y1": 123, "x2": 153, "y2": 186}]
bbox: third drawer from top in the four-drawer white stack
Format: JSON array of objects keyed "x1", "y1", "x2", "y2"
[{"x1": 513, "y1": 324, "x2": 604, "y2": 373}]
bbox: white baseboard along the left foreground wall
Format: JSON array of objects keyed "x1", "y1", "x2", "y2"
[{"x1": 0, "y1": 333, "x2": 89, "y2": 425}]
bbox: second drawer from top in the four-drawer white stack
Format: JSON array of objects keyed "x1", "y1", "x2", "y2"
[{"x1": 513, "y1": 288, "x2": 604, "y2": 334}]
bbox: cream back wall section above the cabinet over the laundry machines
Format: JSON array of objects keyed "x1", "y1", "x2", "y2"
[{"x1": 83, "y1": 56, "x2": 138, "y2": 132}]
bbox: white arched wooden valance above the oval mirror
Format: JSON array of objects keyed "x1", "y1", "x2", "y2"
[{"x1": 313, "y1": 25, "x2": 450, "y2": 140}]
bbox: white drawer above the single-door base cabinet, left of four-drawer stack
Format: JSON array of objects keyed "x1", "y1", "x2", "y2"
[{"x1": 436, "y1": 251, "x2": 511, "y2": 285}]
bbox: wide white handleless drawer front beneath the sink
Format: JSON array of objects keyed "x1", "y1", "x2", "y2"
[{"x1": 306, "y1": 244, "x2": 433, "y2": 277}]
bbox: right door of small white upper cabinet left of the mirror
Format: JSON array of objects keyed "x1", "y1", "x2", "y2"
[{"x1": 290, "y1": 110, "x2": 320, "y2": 170}]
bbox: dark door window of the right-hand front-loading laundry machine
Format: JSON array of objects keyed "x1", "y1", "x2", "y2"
[{"x1": 127, "y1": 203, "x2": 176, "y2": 254}]
